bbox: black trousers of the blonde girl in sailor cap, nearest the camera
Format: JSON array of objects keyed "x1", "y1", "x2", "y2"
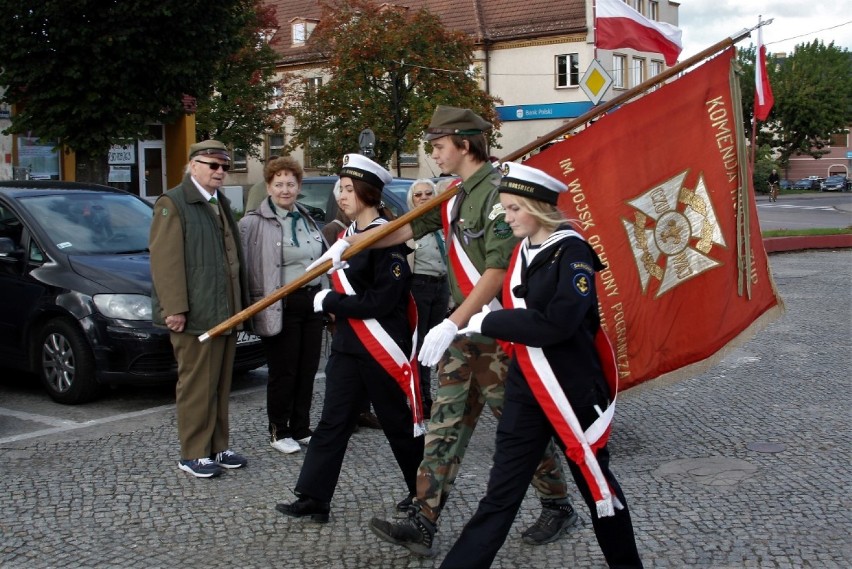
[{"x1": 441, "y1": 384, "x2": 642, "y2": 569}]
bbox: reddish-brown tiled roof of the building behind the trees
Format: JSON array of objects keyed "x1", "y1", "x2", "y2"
[{"x1": 266, "y1": 0, "x2": 588, "y2": 63}]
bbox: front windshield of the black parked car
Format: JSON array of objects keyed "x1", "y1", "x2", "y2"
[{"x1": 19, "y1": 192, "x2": 152, "y2": 255}]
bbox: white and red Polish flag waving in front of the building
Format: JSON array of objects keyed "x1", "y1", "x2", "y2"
[{"x1": 595, "y1": 0, "x2": 683, "y2": 65}]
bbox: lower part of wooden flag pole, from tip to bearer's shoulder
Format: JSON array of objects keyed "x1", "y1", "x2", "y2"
[{"x1": 198, "y1": 184, "x2": 459, "y2": 342}]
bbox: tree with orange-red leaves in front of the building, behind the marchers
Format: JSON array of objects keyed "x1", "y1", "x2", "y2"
[{"x1": 286, "y1": 0, "x2": 500, "y2": 172}]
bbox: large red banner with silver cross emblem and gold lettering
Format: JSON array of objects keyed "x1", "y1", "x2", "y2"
[{"x1": 526, "y1": 48, "x2": 783, "y2": 389}]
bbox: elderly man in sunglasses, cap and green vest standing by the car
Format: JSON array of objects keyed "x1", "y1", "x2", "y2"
[{"x1": 149, "y1": 140, "x2": 248, "y2": 478}]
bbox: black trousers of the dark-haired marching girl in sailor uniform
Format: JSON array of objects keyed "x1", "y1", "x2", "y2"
[{"x1": 296, "y1": 351, "x2": 423, "y2": 502}]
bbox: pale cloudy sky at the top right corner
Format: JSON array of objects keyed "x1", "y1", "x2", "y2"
[{"x1": 678, "y1": 0, "x2": 852, "y2": 61}]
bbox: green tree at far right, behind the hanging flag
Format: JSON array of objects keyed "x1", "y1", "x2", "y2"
[{"x1": 737, "y1": 40, "x2": 852, "y2": 168}]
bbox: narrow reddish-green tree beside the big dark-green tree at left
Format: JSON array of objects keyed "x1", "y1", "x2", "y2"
[{"x1": 196, "y1": 1, "x2": 286, "y2": 158}]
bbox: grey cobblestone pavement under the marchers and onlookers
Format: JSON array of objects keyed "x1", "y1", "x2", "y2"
[{"x1": 0, "y1": 250, "x2": 852, "y2": 569}]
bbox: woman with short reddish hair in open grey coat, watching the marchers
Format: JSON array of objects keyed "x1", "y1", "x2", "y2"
[{"x1": 239, "y1": 156, "x2": 327, "y2": 454}]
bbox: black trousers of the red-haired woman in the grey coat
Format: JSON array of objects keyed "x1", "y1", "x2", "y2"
[{"x1": 261, "y1": 289, "x2": 323, "y2": 439}]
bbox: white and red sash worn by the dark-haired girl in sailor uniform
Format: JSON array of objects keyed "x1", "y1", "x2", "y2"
[{"x1": 331, "y1": 220, "x2": 426, "y2": 437}]
